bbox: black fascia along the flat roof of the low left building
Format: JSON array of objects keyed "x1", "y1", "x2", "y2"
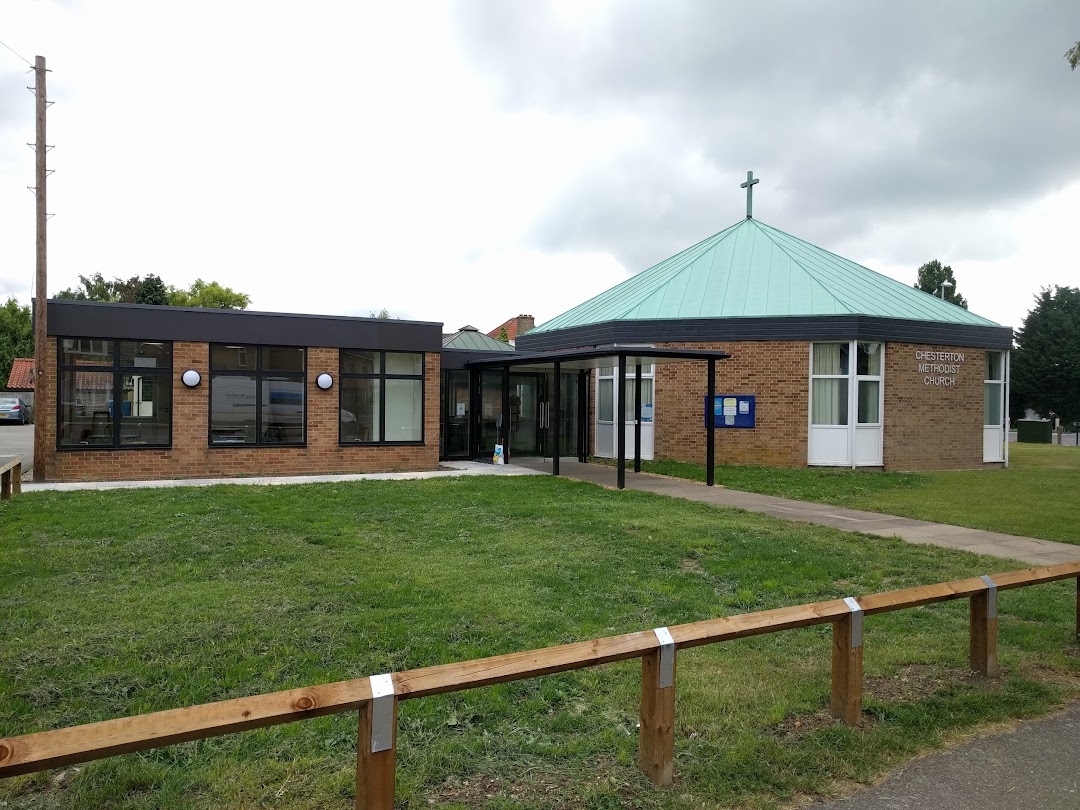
[{"x1": 49, "y1": 299, "x2": 443, "y2": 352}]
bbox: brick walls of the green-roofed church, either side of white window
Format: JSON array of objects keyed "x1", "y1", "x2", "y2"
[{"x1": 630, "y1": 340, "x2": 1000, "y2": 470}]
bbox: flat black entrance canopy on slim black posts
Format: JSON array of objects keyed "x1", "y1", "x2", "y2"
[{"x1": 464, "y1": 346, "x2": 731, "y2": 489}]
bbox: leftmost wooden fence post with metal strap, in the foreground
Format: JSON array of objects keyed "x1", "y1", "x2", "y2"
[{"x1": 356, "y1": 673, "x2": 397, "y2": 810}]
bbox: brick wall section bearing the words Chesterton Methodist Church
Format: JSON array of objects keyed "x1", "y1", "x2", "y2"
[{"x1": 885, "y1": 343, "x2": 1000, "y2": 470}]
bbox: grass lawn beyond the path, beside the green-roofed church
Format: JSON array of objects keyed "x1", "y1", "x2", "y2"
[{"x1": 642, "y1": 444, "x2": 1080, "y2": 543}]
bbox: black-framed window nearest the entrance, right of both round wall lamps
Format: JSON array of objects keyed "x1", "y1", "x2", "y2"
[{"x1": 338, "y1": 349, "x2": 424, "y2": 444}]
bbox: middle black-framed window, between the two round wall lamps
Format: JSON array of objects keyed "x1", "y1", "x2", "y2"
[{"x1": 208, "y1": 343, "x2": 308, "y2": 447}]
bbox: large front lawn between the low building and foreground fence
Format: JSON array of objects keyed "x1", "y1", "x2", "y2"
[{"x1": 0, "y1": 473, "x2": 1080, "y2": 810}]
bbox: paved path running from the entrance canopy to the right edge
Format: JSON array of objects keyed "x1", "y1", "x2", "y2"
[{"x1": 515, "y1": 459, "x2": 1080, "y2": 565}]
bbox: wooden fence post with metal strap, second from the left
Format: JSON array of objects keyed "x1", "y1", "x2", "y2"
[{"x1": 638, "y1": 627, "x2": 675, "y2": 785}]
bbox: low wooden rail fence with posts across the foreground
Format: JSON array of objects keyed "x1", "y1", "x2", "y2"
[{"x1": 0, "y1": 551, "x2": 1080, "y2": 810}]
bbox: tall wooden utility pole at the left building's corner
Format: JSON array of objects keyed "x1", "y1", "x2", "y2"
[{"x1": 33, "y1": 56, "x2": 48, "y2": 481}]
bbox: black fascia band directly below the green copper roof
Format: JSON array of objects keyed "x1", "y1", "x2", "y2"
[{"x1": 517, "y1": 315, "x2": 1013, "y2": 351}]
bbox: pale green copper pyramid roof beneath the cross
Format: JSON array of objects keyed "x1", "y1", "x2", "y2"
[{"x1": 530, "y1": 218, "x2": 998, "y2": 334}]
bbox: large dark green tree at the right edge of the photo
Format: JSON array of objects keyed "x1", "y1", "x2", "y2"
[{"x1": 1012, "y1": 286, "x2": 1080, "y2": 422}]
